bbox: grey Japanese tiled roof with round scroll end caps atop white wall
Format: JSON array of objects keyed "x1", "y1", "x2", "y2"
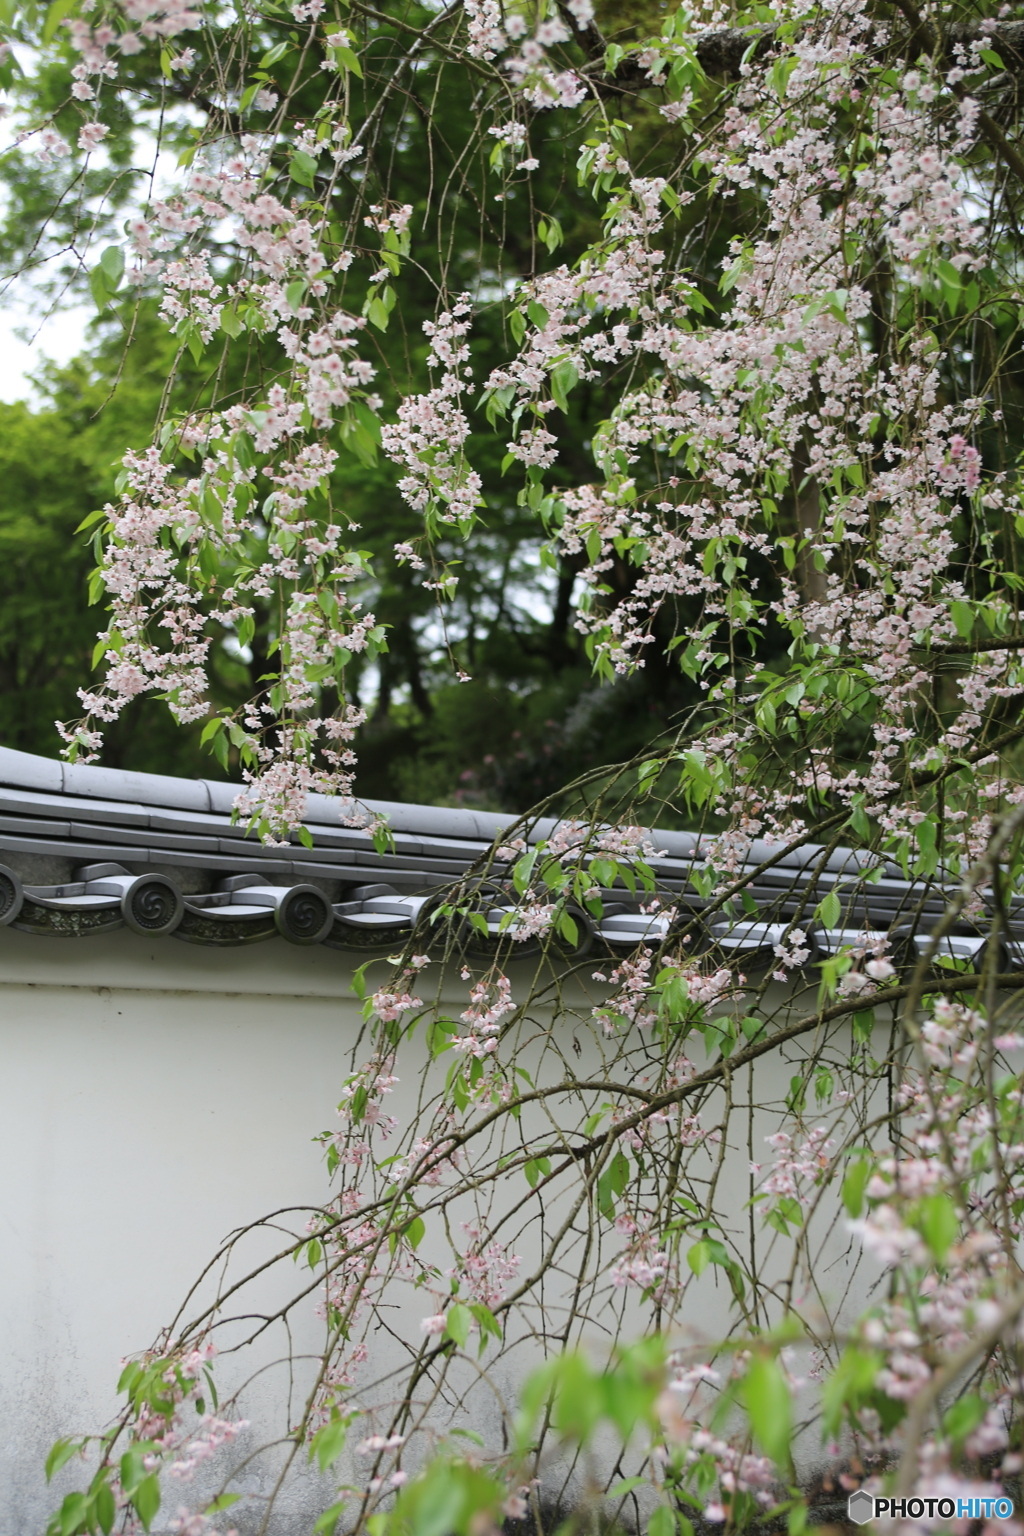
[{"x1": 0, "y1": 748, "x2": 1000, "y2": 965}]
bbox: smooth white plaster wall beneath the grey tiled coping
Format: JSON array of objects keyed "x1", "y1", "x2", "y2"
[{"x1": 0, "y1": 929, "x2": 890, "y2": 1536}]
